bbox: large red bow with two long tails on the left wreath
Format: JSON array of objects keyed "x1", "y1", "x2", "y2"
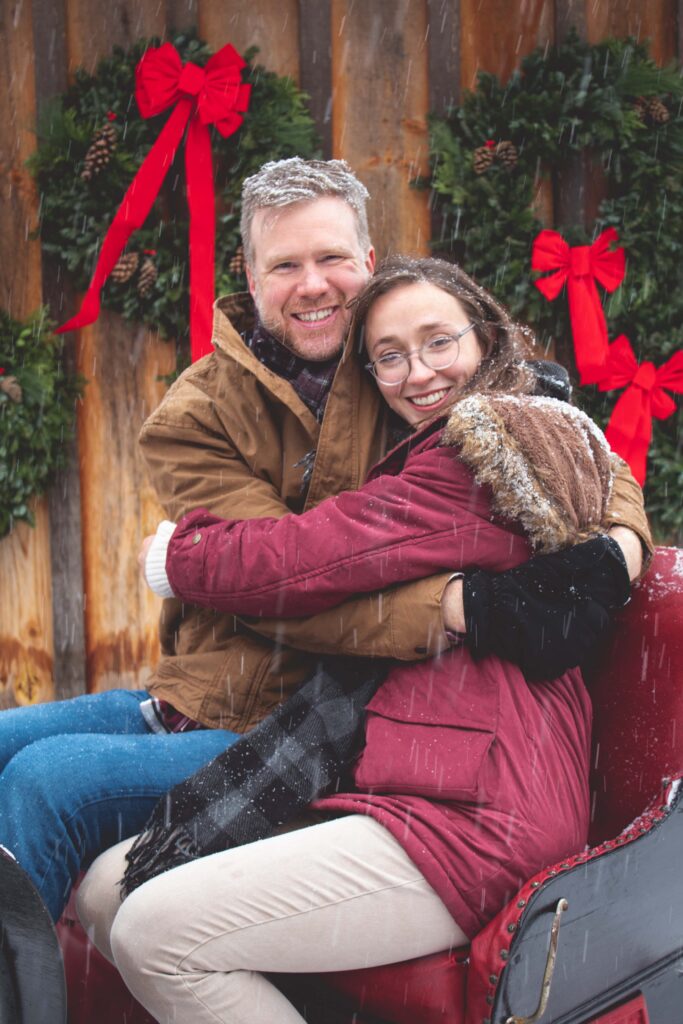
[{"x1": 58, "y1": 43, "x2": 251, "y2": 361}]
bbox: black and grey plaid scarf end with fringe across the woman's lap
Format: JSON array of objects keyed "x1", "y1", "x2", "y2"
[{"x1": 121, "y1": 657, "x2": 386, "y2": 897}]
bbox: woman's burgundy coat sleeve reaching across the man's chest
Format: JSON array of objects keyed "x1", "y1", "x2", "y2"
[{"x1": 167, "y1": 447, "x2": 528, "y2": 616}]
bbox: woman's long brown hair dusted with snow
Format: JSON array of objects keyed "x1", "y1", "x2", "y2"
[{"x1": 352, "y1": 256, "x2": 536, "y2": 397}]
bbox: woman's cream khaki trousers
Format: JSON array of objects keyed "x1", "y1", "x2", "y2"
[{"x1": 81, "y1": 815, "x2": 467, "y2": 1024}]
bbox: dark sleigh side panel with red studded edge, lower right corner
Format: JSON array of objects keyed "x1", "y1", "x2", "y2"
[{"x1": 466, "y1": 776, "x2": 683, "y2": 1024}]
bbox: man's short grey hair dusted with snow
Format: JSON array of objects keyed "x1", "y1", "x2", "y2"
[{"x1": 240, "y1": 157, "x2": 371, "y2": 266}]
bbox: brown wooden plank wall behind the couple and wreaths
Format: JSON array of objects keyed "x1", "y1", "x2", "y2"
[{"x1": 0, "y1": 0, "x2": 683, "y2": 706}]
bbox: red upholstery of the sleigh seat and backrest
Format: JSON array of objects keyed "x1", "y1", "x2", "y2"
[{"x1": 57, "y1": 548, "x2": 683, "y2": 1024}]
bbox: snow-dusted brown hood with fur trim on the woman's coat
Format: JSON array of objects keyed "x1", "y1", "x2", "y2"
[{"x1": 442, "y1": 394, "x2": 614, "y2": 552}]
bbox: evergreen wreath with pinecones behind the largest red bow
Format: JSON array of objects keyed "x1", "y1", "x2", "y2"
[{"x1": 30, "y1": 33, "x2": 316, "y2": 340}]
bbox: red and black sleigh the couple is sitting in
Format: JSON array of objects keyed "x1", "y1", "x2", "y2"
[{"x1": 0, "y1": 548, "x2": 683, "y2": 1024}]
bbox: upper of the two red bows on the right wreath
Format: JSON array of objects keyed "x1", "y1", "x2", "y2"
[{"x1": 531, "y1": 227, "x2": 626, "y2": 384}]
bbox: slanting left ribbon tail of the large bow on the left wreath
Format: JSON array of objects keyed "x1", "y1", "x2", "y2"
[{"x1": 56, "y1": 99, "x2": 193, "y2": 334}]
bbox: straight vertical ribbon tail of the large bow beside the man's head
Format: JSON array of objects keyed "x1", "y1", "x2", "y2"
[{"x1": 185, "y1": 117, "x2": 216, "y2": 362}]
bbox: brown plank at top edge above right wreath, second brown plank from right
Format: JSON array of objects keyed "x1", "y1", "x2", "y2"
[{"x1": 460, "y1": 0, "x2": 560, "y2": 89}]
